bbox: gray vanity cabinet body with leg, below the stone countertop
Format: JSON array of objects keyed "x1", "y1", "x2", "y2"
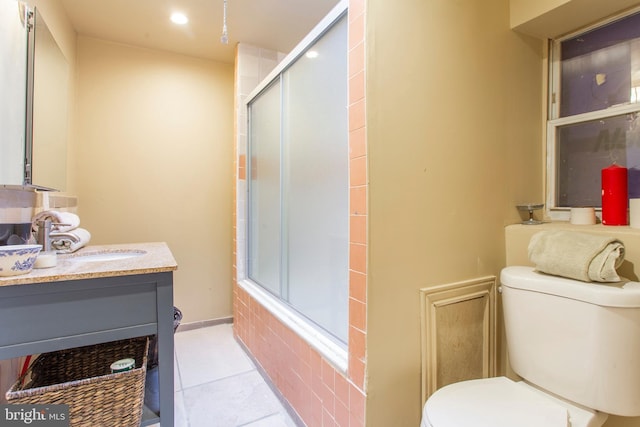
[{"x1": 0, "y1": 271, "x2": 174, "y2": 427}]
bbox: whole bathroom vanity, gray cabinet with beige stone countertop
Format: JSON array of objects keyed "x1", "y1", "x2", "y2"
[{"x1": 0, "y1": 243, "x2": 177, "y2": 427}]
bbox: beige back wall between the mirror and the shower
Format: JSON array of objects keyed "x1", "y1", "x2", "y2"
[{"x1": 72, "y1": 36, "x2": 233, "y2": 323}]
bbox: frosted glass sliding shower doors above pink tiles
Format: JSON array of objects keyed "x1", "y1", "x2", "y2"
[{"x1": 247, "y1": 10, "x2": 349, "y2": 344}]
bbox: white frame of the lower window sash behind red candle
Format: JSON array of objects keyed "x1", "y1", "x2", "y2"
[{"x1": 546, "y1": 103, "x2": 640, "y2": 221}]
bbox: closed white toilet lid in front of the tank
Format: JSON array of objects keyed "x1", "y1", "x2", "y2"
[{"x1": 422, "y1": 377, "x2": 571, "y2": 427}]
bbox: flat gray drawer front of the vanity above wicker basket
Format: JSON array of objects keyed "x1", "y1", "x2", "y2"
[{"x1": 0, "y1": 275, "x2": 171, "y2": 358}]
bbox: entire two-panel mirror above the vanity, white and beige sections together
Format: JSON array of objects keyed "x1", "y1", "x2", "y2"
[{"x1": 0, "y1": 1, "x2": 69, "y2": 190}]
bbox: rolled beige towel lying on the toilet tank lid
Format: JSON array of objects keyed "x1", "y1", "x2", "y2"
[{"x1": 529, "y1": 231, "x2": 624, "y2": 282}]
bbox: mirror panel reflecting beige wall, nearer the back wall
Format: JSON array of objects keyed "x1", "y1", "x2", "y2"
[{"x1": 25, "y1": 8, "x2": 69, "y2": 190}]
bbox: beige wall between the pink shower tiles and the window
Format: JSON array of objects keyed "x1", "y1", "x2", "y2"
[{"x1": 366, "y1": 0, "x2": 543, "y2": 426}]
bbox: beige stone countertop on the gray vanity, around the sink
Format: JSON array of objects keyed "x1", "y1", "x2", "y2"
[{"x1": 0, "y1": 242, "x2": 178, "y2": 286}]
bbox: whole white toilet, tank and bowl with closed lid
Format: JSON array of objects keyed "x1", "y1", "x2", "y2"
[{"x1": 420, "y1": 266, "x2": 640, "y2": 427}]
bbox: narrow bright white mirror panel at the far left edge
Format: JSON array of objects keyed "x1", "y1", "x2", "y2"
[{"x1": 0, "y1": 1, "x2": 28, "y2": 185}]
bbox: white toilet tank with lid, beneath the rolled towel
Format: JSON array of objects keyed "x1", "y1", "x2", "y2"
[{"x1": 500, "y1": 267, "x2": 640, "y2": 416}]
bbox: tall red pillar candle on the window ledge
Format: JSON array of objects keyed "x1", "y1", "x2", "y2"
[{"x1": 602, "y1": 164, "x2": 628, "y2": 225}]
